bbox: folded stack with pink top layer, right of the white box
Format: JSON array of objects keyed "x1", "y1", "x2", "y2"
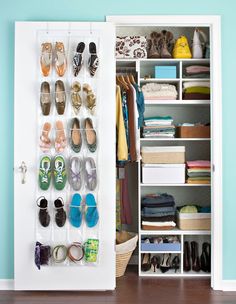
[{"x1": 187, "y1": 160, "x2": 211, "y2": 184}]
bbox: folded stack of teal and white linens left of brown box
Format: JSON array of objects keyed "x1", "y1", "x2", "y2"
[{"x1": 143, "y1": 116, "x2": 175, "y2": 137}]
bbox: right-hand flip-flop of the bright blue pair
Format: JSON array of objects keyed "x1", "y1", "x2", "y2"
[{"x1": 85, "y1": 193, "x2": 99, "y2": 228}]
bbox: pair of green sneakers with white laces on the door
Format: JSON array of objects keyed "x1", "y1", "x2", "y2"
[{"x1": 38, "y1": 155, "x2": 67, "y2": 191}]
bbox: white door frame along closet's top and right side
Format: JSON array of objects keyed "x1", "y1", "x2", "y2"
[{"x1": 106, "y1": 15, "x2": 223, "y2": 290}]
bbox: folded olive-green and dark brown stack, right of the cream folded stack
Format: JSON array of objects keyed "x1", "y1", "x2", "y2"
[{"x1": 183, "y1": 81, "x2": 211, "y2": 100}]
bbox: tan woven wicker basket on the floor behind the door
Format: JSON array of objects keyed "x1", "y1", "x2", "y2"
[{"x1": 116, "y1": 233, "x2": 138, "y2": 278}]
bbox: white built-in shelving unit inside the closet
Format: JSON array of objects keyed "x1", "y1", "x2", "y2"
[{"x1": 116, "y1": 25, "x2": 211, "y2": 277}]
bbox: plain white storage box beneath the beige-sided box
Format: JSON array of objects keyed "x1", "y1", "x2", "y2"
[{"x1": 142, "y1": 164, "x2": 185, "y2": 184}]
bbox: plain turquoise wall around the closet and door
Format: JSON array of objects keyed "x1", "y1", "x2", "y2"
[{"x1": 0, "y1": 0, "x2": 236, "y2": 279}]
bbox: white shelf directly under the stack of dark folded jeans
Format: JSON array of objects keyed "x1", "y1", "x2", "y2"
[{"x1": 140, "y1": 228, "x2": 211, "y2": 235}]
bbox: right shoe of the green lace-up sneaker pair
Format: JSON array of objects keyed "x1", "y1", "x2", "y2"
[{"x1": 53, "y1": 155, "x2": 67, "y2": 190}]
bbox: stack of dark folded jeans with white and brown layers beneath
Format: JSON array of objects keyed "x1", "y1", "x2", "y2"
[{"x1": 141, "y1": 193, "x2": 176, "y2": 230}]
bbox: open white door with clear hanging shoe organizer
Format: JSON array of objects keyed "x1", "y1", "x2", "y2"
[{"x1": 14, "y1": 22, "x2": 115, "y2": 290}]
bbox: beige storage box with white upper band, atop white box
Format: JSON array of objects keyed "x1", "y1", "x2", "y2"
[{"x1": 141, "y1": 146, "x2": 185, "y2": 164}]
